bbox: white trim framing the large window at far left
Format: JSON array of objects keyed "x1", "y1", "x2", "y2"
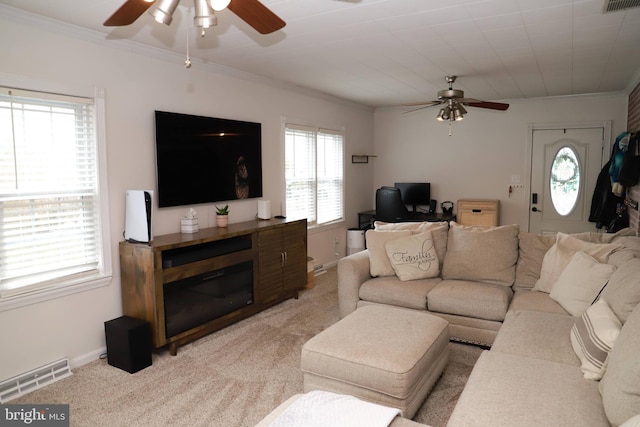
[{"x1": 0, "y1": 88, "x2": 113, "y2": 312}]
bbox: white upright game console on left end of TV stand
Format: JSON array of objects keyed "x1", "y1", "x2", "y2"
[{"x1": 124, "y1": 190, "x2": 153, "y2": 243}]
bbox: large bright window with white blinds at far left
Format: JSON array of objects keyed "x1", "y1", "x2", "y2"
[{"x1": 0, "y1": 87, "x2": 111, "y2": 308}]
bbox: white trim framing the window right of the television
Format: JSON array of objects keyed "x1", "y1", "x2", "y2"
[{"x1": 281, "y1": 117, "x2": 347, "y2": 229}]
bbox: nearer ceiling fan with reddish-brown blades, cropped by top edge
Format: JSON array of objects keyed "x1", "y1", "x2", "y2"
[{"x1": 104, "y1": 0, "x2": 286, "y2": 34}]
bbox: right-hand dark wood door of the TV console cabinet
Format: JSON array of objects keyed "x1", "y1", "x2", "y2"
[{"x1": 282, "y1": 221, "x2": 307, "y2": 290}]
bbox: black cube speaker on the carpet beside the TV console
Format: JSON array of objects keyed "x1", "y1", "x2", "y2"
[{"x1": 104, "y1": 316, "x2": 151, "y2": 374}]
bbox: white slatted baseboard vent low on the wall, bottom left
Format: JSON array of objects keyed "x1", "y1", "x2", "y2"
[{"x1": 0, "y1": 359, "x2": 72, "y2": 403}]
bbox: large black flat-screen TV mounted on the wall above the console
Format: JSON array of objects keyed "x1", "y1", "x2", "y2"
[{"x1": 155, "y1": 111, "x2": 262, "y2": 208}]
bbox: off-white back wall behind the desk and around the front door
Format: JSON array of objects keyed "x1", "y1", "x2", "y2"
[{"x1": 372, "y1": 94, "x2": 627, "y2": 229}]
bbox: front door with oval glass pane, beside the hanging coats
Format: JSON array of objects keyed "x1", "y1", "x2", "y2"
[{"x1": 529, "y1": 125, "x2": 608, "y2": 233}]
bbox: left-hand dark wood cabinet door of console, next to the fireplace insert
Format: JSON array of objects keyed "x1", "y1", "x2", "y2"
[{"x1": 258, "y1": 228, "x2": 284, "y2": 302}]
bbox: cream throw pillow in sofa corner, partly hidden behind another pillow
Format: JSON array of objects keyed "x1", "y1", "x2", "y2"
[{"x1": 533, "y1": 233, "x2": 621, "y2": 293}]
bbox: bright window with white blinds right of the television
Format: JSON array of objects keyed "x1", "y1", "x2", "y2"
[{"x1": 285, "y1": 123, "x2": 344, "y2": 227}]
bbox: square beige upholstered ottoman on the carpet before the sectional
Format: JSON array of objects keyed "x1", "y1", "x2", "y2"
[{"x1": 300, "y1": 305, "x2": 449, "y2": 418}]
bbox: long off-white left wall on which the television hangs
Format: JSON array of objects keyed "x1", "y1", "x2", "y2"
[{"x1": 0, "y1": 10, "x2": 373, "y2": 380}]
